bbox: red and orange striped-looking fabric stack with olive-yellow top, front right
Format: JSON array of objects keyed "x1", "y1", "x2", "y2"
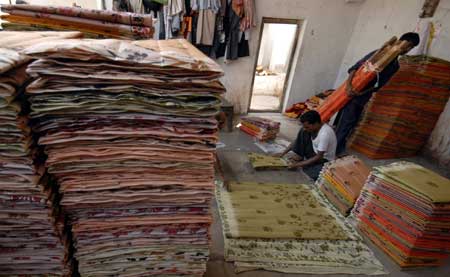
[{"x1": 352, "y1": 162, "x2": 450, "y2": 267}]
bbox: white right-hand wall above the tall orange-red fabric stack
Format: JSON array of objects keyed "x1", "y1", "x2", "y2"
[{"x1": 335, "y1": 0, "x2": 450, "y2": 87}]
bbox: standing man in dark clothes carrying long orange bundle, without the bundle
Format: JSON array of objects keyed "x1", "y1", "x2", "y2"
[{"x1": 335, "y1": 33, "x2": 420, "y2": 155}]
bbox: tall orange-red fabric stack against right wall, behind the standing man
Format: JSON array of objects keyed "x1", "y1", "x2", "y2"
[{"x1": 350, "y1": 56, "x2": 450, "y2": 159}]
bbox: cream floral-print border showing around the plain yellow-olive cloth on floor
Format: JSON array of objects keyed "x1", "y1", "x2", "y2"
[{"x1": 216, "y1": 181, "x2": 386, "y2": 275}]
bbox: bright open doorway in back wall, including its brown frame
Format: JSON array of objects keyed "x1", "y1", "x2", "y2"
[{"x1": 249, "y1": 17, "x2": 301, "y2": 112}]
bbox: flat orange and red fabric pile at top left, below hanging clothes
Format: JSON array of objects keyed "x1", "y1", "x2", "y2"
[{"x1": 1, "y1": 4, "x2": 154, "y2": 39}]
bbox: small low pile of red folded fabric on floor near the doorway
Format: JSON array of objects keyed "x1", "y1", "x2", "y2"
[{"x1": 239, "y1": 116, "x2": 280, "y2": 141}]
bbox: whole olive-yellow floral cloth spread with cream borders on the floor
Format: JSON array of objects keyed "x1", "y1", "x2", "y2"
[{"x1": 216, "y1": 180, "x2": 385, "y2": 275}]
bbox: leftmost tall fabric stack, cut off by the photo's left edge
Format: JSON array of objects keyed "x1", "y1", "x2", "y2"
[{"x1": 0, "y1": 48, "x2": 71, "y2": 276}]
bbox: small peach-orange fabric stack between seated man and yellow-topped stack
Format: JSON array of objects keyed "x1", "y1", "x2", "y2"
[{"x1": 316, "y1": 156, "x2": 370, "y2": 216}]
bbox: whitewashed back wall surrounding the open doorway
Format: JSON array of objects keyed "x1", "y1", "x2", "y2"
[{"x1": 219, "y1": 0, "x2": 361, "y2": 113}]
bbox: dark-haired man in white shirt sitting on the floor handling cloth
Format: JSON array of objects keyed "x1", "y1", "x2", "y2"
[{"x1": 279, "y1": 111, "x2": 336, "y2": 180}]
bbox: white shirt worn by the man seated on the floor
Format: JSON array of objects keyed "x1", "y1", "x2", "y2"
[{"x1": 312, "y1": 123, "x2": 337, "y2": 161}]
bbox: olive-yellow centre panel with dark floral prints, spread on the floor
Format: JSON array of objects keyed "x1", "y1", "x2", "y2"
[{"x1": 221, "y1": 183, "x2": 348, "y2": 240}]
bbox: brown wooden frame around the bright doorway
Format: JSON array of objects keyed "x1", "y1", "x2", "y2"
[{"x1": 247, "y1": 17, "x2": 303, "y2": 113}]
